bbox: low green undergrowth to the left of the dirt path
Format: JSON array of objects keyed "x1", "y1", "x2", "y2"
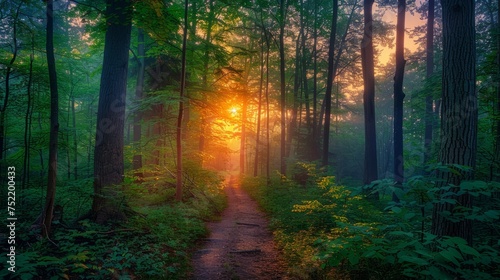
[{"x1": 0, "y1": 165, "x2": 225, "y2": 279}]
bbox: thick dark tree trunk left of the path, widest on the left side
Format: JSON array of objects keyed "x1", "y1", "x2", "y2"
[{"x1": 91, "y1": 0, "x2": 132, "y2": 223}]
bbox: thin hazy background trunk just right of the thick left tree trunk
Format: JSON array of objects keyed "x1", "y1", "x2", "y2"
[{"x1": 132, "y1": 28, "x2": 146, "y2": 179}]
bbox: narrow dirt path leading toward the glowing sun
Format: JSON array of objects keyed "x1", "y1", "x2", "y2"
[{"x1": 193, "y1": 178, "x2": 290, "y2": 280}]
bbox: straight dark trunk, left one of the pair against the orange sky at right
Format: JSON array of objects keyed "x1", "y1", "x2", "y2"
[{"x1": 361, "y1": 0, "x2": 378, "y2": 191}]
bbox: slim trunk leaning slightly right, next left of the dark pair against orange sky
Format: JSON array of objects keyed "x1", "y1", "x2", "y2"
[{"x1": 322, "y1": 0, "x2": 339, "y2": 166}]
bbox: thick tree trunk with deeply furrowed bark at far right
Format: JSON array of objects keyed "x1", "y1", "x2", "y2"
[{"x1": 432, "y1": 0, "x2": 478, "y2": 244}]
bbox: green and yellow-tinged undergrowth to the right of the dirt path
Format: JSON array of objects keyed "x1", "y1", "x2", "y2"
[{"x1": 243, "y1": 164, "x2": 500, "y2": 279}]
